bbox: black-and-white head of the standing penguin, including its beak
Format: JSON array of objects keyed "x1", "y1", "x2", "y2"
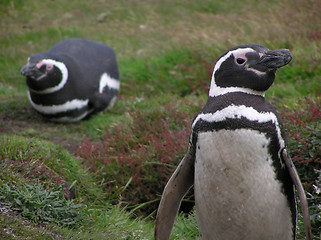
[{"x1": 209, "y1": 45, "x2": 292, "y2": 97}]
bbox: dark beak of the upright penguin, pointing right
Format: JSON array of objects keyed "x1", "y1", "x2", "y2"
[{"x1": 259, "y1": 49, "x2": 292, "y2": 70}]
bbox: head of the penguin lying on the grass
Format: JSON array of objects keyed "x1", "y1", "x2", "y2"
[{"x1": 21, "y1": 54, "x2": 68, "y2": 93}]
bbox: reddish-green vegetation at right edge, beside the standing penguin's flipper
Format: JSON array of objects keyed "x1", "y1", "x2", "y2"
[{"x1": 281, "y1": 95, "x2": 321, "y2": 236}]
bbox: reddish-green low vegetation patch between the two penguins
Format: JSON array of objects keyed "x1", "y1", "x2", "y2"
[{"x1": 77, "y1": 104, "x2": 199, "y2": 209}]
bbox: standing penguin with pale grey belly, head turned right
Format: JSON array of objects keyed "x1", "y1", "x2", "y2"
[{"x1": 155, "y1": 45, "x2": 311, "y2": 240}]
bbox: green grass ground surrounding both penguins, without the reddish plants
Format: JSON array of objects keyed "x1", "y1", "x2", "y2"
[{"x1": 0, "y1": 0, "x2": 321, "y2": 239}]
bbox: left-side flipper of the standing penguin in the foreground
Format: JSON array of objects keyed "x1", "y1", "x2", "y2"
[{"x1": 155, "y1": 145, "x2": 195, "y2": 240}]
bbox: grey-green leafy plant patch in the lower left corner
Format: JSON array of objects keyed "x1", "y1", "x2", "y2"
[{"x1": 0, "y1": 184, "x2": 83, "y2": 228}]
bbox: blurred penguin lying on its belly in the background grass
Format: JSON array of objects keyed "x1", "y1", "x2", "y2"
[{"x1": 21, "y1": 39, "x2": 120, "y2": 123}]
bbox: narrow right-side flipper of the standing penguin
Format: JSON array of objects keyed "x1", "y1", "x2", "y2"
[{"x1": 282, "y1": 148, "x2": 312, "y2": 240}]
